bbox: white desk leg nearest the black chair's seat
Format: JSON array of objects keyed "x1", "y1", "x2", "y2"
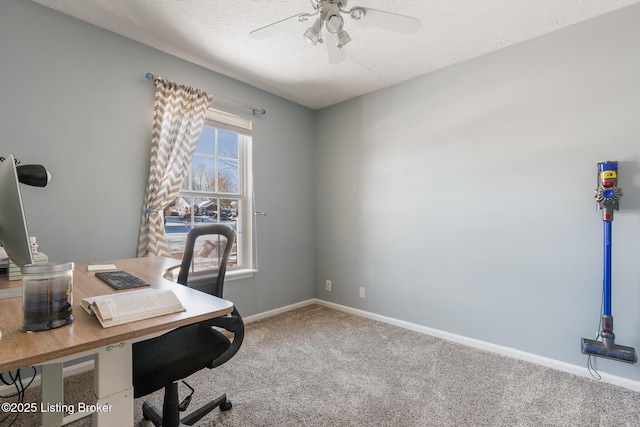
[{"x1": 93, "y1": 342, "x2": 133, "y2": 427}]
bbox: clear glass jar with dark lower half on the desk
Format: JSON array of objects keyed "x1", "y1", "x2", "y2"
[{"x1": 20, "y1": 262, "x2": 73, "y2": 331}]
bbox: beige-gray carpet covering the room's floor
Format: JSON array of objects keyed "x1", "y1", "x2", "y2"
[{"x1": 3, "y1": 305, "x2": 640, "y2": 427}]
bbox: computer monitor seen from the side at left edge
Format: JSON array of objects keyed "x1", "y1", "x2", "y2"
[{"x1": 0, "y1": 154, "x2": 34, "y2": 268}]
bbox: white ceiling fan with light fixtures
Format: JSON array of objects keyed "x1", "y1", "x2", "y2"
[{"x1": 249, "y1": 0, "x2": 420, "y2": 64}]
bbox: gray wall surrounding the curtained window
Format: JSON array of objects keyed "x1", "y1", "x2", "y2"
[{"x1": 0, "y1": 0, "x2": 316, "y2": 315}]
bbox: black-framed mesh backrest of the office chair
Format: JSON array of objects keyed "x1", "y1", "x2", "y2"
[{"x1": 177, "y1": 224, "x2": 236, "y2": 298}]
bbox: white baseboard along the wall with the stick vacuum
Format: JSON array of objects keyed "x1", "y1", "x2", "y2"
[{"x1": 313, "y1": 298, "x2": 640, "y2": 392}]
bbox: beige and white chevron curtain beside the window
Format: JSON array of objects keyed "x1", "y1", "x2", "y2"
[{"x1": 138, "y1": 77, "x2": 212, "y2": 257}]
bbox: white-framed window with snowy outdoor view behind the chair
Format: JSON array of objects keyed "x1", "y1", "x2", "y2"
[{"x1": 164, "y1": 109, "x2": 253, "y2": 270}]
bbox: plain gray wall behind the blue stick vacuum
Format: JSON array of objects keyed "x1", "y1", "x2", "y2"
[{"x1": 316, "y1": 5, "x2": 640, "y2": 380}]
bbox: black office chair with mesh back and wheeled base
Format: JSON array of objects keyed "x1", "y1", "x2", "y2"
[{"x1": 132, "y1": 224, "x2": 244, "y2": 427}]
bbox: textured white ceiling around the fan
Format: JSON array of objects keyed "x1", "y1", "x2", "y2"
[{"x1": 33, "y1": 0, "x2": 640, "y2": 109}]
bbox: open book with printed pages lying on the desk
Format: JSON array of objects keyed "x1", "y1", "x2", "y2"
[{"x1": 80, "y1": 289, "x2": 186, "y2": 328}]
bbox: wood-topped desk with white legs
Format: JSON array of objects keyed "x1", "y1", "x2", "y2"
[{"x1": 0, "y1": 257, "x2": 233, "y2": 427}]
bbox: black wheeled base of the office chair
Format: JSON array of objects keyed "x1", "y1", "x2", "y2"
[{"x1": 142, "y1": 383, "x2": 233, "y2": 427}]
